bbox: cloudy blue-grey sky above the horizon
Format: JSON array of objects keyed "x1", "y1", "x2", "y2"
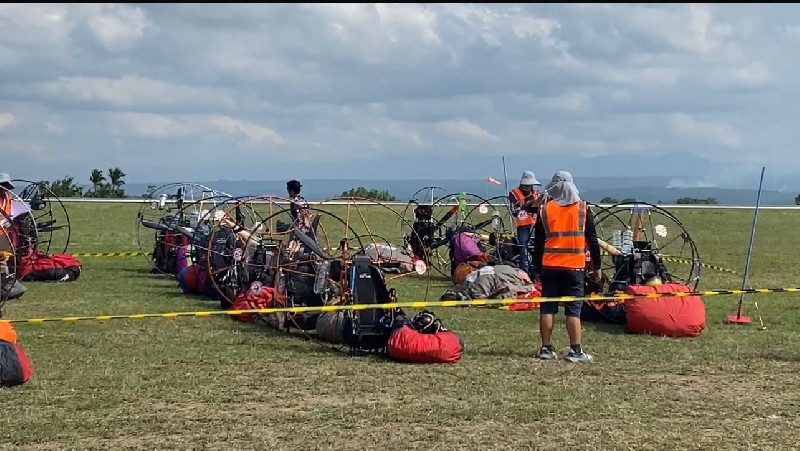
[{"x1": 0, "y1": 4, "x2": 800, "y2": 185}]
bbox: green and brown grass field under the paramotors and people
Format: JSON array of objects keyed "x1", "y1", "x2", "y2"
[{"x1": 0, "y1": 204, "x2": 800, "y2": 450}]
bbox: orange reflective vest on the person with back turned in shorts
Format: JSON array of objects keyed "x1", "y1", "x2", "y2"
[{"x1": 539, "y1": 201, "x2": 588, "y2": 269}]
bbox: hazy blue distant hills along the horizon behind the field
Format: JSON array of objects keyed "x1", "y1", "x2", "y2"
[{"x1": 120, "y1": 176, "x2": 798, "y2": 206}]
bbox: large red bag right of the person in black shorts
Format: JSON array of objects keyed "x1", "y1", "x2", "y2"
[{"x1": 624, "y1": 282, "x2": 706, "y2": 337}]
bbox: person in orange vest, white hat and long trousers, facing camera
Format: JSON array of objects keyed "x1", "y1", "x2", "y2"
[{"x1": 508, "y1": 171, "x2": 542, "y2": 273}]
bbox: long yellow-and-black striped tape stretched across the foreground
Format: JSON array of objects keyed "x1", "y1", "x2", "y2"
[{"x1": 0, "y1": 287, "x2": 800, "y2": 324}]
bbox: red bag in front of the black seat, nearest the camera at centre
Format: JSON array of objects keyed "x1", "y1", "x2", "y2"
[{"x1": 387, "y1": 326, "x2": 464, "y2": 363}]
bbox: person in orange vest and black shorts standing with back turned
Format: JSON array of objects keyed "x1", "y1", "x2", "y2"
[{"x1": 533, "y1": 171, "x2": 602, "y2": 363}]
